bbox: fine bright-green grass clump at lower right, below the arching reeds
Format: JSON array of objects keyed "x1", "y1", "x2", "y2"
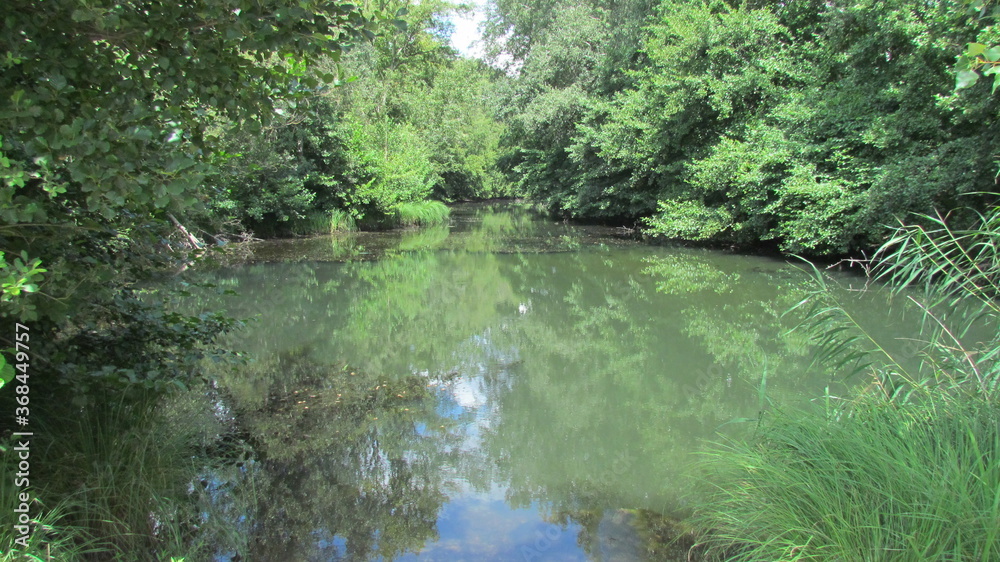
[{"x1": 698, "y1": 399, "x2": 1000, "y2": 562}]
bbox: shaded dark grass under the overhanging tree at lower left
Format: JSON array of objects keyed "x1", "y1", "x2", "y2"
[{"x1": 0, "y1": 393, "x2": 250, "y2": 562}]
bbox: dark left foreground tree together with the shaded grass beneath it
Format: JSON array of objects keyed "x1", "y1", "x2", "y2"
[{"x1": 0, "y1": 0, "x2": 406, "y2": 560}]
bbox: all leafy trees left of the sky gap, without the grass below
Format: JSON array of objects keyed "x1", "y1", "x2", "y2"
[{"x1": 0, "y1": 0, "x2": 502, "y2": 393}]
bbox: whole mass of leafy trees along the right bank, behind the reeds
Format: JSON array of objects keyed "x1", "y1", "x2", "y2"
[{"x1": 492, "y1": 0, "x2": 998, "y2": 254}]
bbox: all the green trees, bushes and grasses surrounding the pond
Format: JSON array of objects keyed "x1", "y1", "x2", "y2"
[{"x1": 0, "y1": 0, "x2": 1000, "y2": 561}]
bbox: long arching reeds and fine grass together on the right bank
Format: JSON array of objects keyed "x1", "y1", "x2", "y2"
[{"x1": 696, "y1": 199, "x2": 1000, "y2": 561}]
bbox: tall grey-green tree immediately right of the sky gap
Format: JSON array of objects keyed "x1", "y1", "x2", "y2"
[{"x1": 486, "y1": 0, "x2": 655, "y2": 218}]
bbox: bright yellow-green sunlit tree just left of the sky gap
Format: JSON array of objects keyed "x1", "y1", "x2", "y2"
[{"x1": 344, "y1": 1, "x2": 502, "y2": 207}]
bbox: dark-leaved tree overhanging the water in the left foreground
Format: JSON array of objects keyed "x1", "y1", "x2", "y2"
[{"x1": 0, "y1": 0, "x2": 389, "y2": 390}]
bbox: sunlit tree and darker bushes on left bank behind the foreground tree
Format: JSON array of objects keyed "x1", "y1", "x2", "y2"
[{"x1": 211, "y1": 2, "x2": 505, "y2": 235}]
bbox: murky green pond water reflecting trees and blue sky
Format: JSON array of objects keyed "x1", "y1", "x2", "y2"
[{"x1": 184, "y1": 205, "x2": 913, "y2": 561}]
